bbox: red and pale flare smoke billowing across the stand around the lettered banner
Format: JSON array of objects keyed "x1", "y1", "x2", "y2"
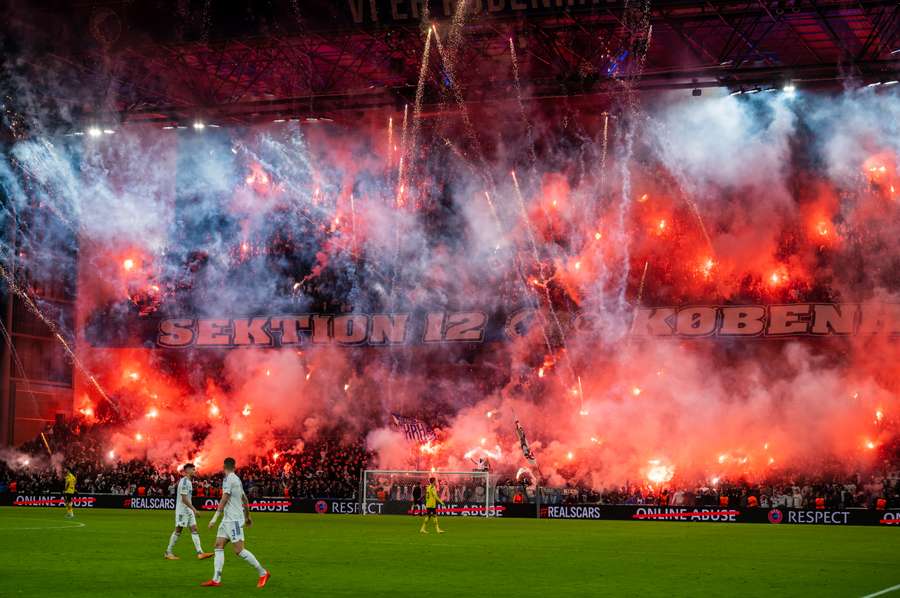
[{"x1": 17, "y1": 89, "x2": 888, "y2": 488}]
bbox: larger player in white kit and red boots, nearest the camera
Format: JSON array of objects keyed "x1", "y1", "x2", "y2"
[{"x1": 200, "y1": 457, "x2": 269, "y2": 588}]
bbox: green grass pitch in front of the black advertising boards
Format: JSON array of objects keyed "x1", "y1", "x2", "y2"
[{"x1": 0, "y1": 507, "x2": 900, "y2": 598}]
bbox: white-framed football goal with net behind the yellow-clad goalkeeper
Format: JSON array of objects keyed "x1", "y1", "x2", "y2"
[{"x1": 359, "y1": 469, "x2": 496, "y2": 517}]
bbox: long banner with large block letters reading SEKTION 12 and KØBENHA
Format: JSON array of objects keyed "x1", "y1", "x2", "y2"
[{"x1": 85, "y1": 303, "x2": 900, "y2": 349}]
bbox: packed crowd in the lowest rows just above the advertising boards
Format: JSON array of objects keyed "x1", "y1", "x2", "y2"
[{"x1": 0, "y1": 422, "x2": 900, "y2": 508}]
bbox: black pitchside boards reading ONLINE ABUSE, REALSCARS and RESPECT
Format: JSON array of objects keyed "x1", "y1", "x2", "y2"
[{"x1": 0, "y1": 493, "x2": 900, "y2": 527}]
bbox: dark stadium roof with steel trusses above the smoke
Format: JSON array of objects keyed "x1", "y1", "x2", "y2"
[{"x1": 5, "y1": 0, "x2": 900, "y2": 124}]
